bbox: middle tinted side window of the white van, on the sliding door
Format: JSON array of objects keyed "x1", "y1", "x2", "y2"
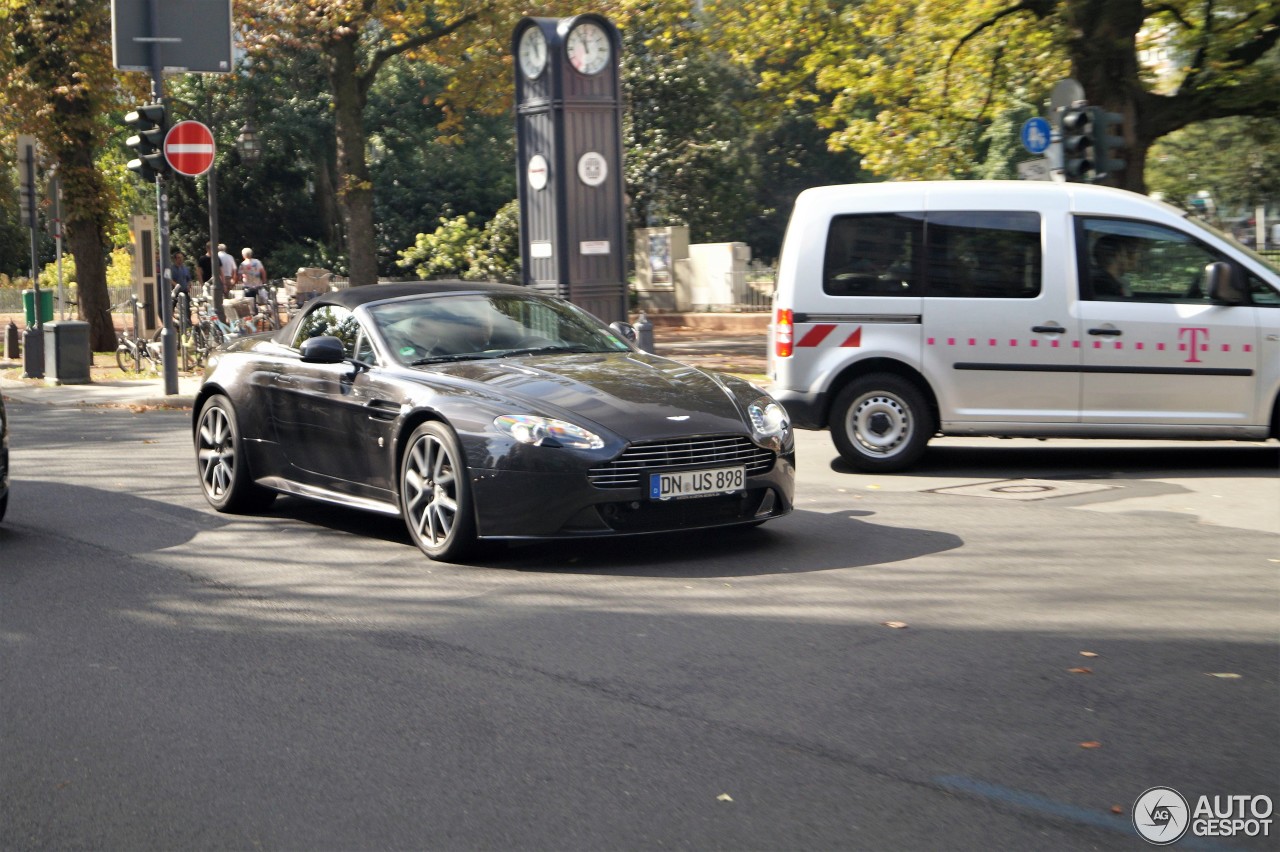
[{"x1": 925, "y1": 211, "x2": 1041, "y2": 299}]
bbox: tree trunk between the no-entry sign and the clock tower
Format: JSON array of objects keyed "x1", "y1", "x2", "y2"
[{"x1": 325, "y1": 33, "x2": 378, "y2": 287}]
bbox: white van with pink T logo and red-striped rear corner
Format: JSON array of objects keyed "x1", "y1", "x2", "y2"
[{"x1": 769, "y1": 180, "x2": 1280, "y2": 471}]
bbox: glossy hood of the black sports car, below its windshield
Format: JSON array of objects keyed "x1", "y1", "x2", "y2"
[{"x1": 419, "y1": 352, "x2": 748, "y2": 440}]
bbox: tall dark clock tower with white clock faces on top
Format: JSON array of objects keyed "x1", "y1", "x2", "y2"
[{"x1": 512, "y1": 14, "x2": 627, "y2": 322}]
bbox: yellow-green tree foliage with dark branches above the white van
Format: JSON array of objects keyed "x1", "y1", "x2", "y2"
[{"x1": 708, "y1": 0, "x2": 1280, "y2": 191}]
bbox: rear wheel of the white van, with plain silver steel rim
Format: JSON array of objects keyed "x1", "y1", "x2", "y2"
[{"x1": 829, "y1": 372, "x2": 937, "y2": 472}]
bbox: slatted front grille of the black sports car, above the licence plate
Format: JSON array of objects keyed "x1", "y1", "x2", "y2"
[{"x1": 588, "y1": 436, "x2": 774, "y2": 489}]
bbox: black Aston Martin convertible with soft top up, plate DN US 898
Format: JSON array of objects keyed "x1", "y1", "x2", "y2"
[{"x1": 192, "y1": 281, "x2": 795, "y2": 559}]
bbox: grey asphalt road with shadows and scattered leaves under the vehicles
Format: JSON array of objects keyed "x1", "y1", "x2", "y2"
[{"x1": 0, "y1": 403, "x2": 1280, "y2": 849}]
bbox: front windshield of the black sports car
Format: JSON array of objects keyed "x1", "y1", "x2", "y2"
[{"x1": 369, "y1": 293, "x2": 630, "y2": 366}]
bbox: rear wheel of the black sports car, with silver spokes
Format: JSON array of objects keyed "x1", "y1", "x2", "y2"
[{"x1": 196, "y1": 394, "x2": 275, "y2": 513}]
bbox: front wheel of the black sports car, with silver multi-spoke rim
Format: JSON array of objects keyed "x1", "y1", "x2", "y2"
[{"x1": 399, "y1": 421, "x2": 476, "y2": 562}]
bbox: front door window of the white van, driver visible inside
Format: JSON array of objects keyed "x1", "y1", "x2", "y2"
[{"x1": 1076, "y1": 217, "x2": 1268, "y2": 304}]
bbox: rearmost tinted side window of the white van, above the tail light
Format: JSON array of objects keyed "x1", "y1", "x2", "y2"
[{"x1": 822, "y1": 214, "x2": 924, "y2": 296}]
